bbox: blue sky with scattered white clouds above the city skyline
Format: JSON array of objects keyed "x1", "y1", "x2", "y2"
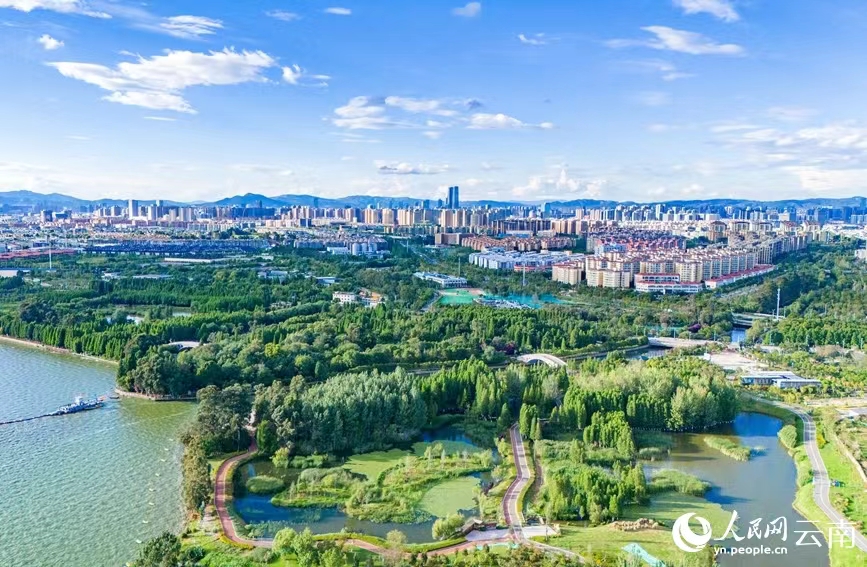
[{"x1": 0, "y1": 0, "x2": 867, "y2": 201}]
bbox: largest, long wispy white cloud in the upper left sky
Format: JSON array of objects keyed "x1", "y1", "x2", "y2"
[{"x1": 48, "y1": 48, "x2": 277, "y2": 114}]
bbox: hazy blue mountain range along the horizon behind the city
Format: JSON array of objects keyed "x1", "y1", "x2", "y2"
[{"x1": 0, "y1": 190, "x2": 867, "y2": 211}]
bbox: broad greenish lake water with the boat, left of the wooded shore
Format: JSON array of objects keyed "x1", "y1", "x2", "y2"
[{"x1": 0, "y1": 342, "x2": 195, "y2": 567}]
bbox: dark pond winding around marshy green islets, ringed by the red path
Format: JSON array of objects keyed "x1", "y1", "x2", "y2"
[{"x1": 234, "y1": 425, "x2": 491, "y2": 543}]
